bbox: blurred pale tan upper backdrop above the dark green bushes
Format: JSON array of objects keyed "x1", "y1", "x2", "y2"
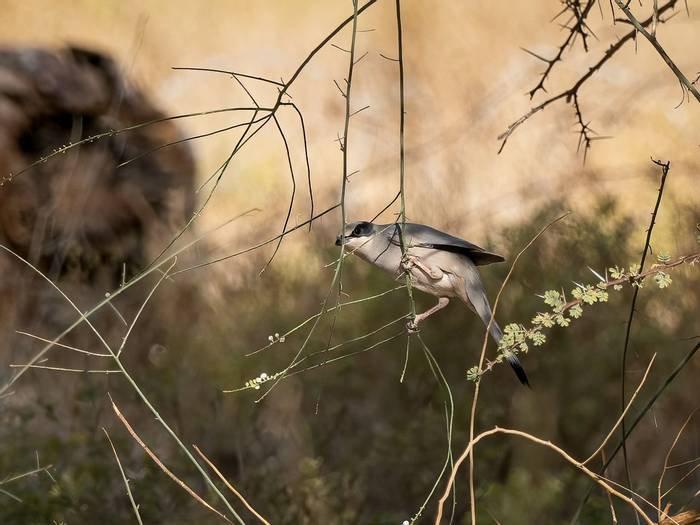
[{"x1": 0, "y1": 1, "x2": 700, "y2": 270}]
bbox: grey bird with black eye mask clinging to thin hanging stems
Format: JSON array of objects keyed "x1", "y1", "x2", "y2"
[{"x1": 335, "y1": 221, "x2": 530, "y2": 386}]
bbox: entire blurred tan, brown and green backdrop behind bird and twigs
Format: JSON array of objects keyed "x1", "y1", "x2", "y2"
[{"x1": 0, "y1": 0, "x2": 700, "y2": 524}]
